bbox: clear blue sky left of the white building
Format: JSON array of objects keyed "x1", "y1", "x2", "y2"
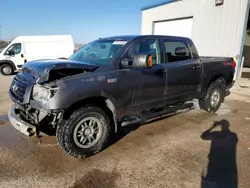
[{"x1": 0, "y1": 0, "x2": 167, "y2": 43}]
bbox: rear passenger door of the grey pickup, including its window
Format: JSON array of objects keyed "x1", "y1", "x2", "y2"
[{"x1": 162, "y1": 37, "x2": 202, "y2": 103}]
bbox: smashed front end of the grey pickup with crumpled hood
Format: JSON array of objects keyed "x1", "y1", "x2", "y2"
[{"x1": 9, "y1": 60, "x2": 97, "y2": 136}]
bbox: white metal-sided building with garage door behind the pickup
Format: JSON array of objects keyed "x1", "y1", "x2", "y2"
[{"x1": 141, "y1": 0, "x2": 250, "y2": 77}]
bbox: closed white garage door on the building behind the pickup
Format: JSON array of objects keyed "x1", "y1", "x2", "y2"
[{"x1": 154, "y1": 18, "x2": 193, "y2": 38}]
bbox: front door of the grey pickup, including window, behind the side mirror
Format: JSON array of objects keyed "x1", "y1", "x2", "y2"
[{"x1": 118, "y1": 38, "x2": 166, "y2": 115}]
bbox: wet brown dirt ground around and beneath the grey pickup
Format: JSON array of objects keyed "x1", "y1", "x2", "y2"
[{"x1": 0, "y1": 76, "x2": 250, "y2": 188}]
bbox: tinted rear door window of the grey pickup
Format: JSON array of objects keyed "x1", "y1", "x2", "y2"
[{"x1": 163, "y1": 39, "x2": 192, "y2": 62}]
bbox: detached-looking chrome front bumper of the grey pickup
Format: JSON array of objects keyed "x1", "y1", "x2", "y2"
[{"x1": 8, "y1": 104, "x2": 36, "y2": 136}]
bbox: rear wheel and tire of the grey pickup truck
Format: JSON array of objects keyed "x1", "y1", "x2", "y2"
[{"x1": 199, "y1": 78, "x2": 226, "y2": 113}]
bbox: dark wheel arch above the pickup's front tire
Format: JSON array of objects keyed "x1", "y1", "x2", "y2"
[{"x1": 63, "y1": 96, "x2": 117, "y2": 132}]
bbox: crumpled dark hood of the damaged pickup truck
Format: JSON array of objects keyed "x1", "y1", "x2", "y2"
[{"x1": 21, "y1": 59, "x2": 99, "y2": 83}]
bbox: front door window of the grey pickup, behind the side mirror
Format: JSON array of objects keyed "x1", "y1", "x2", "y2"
[{"x1": 127, "y1": 39, "x2": 160, "y2": 65}]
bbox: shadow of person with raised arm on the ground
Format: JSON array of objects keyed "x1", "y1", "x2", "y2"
[{"x1": 201, "y1": 120, "x2": 238, "y2": 188}]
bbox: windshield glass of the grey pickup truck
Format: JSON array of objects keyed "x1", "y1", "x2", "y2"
[{"x1": 69, "y1": 39, "x2": 127, "y2": 65}]
